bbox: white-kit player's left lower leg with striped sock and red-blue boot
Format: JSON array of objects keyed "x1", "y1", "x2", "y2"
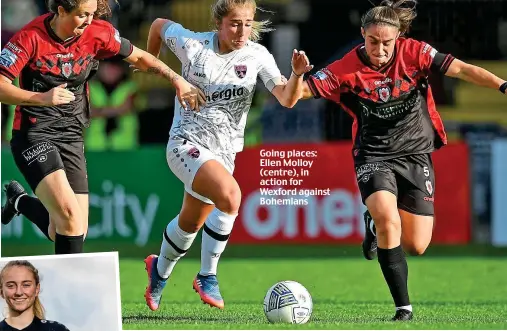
[{"x1": 144, "y1": 215, "x2": 197, "y2": 310}]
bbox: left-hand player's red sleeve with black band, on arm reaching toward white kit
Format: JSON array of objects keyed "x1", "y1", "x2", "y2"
[{"x1": 96, "y1": 22, "x2": 134, "y2": 59}]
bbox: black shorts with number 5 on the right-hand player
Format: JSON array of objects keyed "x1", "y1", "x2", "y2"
[{"x1": 355, "y1": 154, "x2": 435, "y2": 216}]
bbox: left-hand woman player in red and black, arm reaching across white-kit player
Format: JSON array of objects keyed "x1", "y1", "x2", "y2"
[{"x1": 0, "y1": 0, "x2": 204, "y2": 254}]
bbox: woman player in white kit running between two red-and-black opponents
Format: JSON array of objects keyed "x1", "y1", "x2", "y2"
[{"x1": 145, "y1": 0, "x2": 313, "y2": 310}]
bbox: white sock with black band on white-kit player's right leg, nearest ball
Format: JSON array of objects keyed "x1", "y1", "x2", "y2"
[{"x1": 199, "y1": 208, "x2": 238, "y2": 276}]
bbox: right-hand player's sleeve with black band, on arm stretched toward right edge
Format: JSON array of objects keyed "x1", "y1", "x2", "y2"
[{"x1": 412, "y1": 40, "x2": 454, "y2": 74}]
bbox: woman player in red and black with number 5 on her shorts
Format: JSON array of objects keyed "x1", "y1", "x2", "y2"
[{"x1": 301, "y1": 0, "x2": 507, "y2": 320}]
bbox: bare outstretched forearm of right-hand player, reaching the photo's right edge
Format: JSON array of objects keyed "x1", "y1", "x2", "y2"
[{"x1": 446, "y1": 59, "x2": 506, "y2": 93}]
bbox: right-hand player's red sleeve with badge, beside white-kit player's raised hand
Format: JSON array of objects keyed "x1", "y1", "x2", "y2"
[{"x1": 307, "y1": 60, "x2": 342, "y2": 103}]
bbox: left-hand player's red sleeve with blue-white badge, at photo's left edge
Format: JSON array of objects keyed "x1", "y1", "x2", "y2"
[{"x1": 0, "y1": 30, "x2": 35, "y2": 80}]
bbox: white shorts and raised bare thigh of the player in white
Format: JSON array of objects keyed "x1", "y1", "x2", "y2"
[{"x1": 167, "y1": 140, "x2": 241, "y2": 213}]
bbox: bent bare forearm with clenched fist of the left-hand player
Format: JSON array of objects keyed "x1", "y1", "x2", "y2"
[{"x1": 0, "y1": 75, "x2": 75, "y2": 106}]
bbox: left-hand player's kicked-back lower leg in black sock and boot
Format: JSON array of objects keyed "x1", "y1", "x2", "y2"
[{"x1": 2, "y1": 180, "x2": 53, "y2": 241}]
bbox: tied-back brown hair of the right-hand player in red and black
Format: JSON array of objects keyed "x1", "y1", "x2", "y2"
[{"x1": 361, "y1": 0, "x2": 417, "y2": 35}]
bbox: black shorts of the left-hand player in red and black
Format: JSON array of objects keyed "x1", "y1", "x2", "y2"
[{"x1": 11, "y1": 135, "x2": 88, "y2": 194}]
